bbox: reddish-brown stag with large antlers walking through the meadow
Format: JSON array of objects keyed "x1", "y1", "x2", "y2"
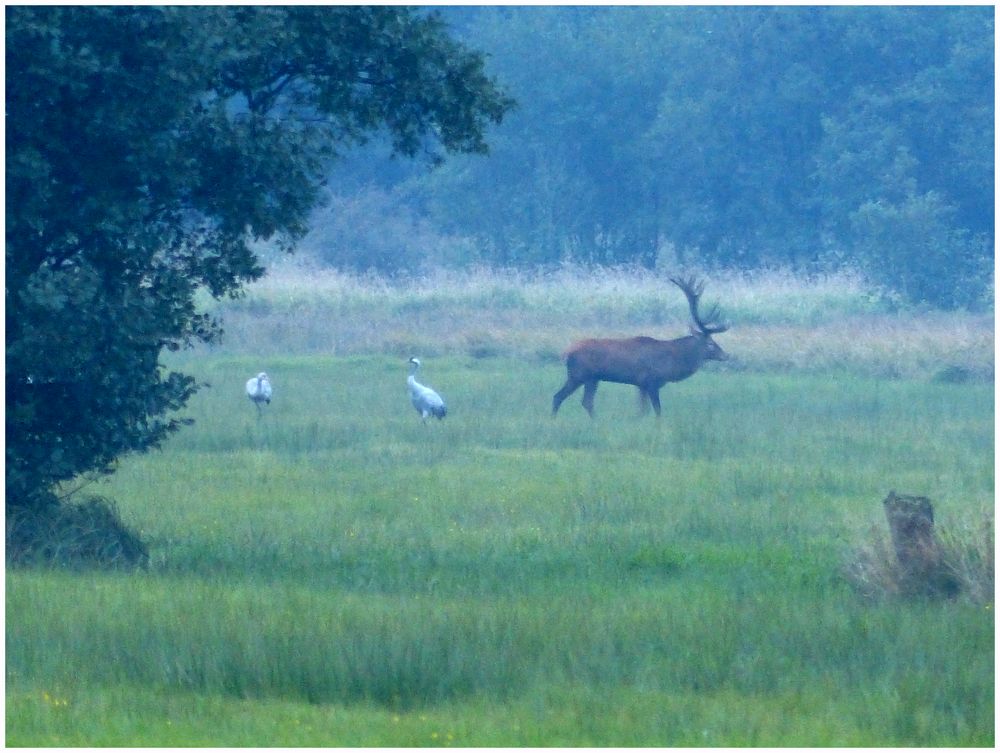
[{"x1": 552, "y1": 277, "x2": 729, "y2": 418}]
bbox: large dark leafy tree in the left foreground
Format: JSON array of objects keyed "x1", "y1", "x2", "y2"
[{"x1": 5, "y1": 7, "x2": 512, "y2": 511}]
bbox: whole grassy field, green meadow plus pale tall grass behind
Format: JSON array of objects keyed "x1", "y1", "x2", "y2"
[{"x1": 6, "y1": 270, "x2": 994, "y2": 747}]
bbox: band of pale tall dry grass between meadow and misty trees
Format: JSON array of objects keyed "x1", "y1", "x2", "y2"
[{"x1": 197, "y1": 261, "x2": 994, "y2": 381}]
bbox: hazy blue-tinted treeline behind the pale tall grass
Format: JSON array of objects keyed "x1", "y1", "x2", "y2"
[{"x1": 303, "y1": 7, "x2": 994, "y2": 307}]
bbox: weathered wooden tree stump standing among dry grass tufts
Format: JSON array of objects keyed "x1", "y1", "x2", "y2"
[{"x1": 882, "y1": 491, "x2": 958, "y2": 596}]
